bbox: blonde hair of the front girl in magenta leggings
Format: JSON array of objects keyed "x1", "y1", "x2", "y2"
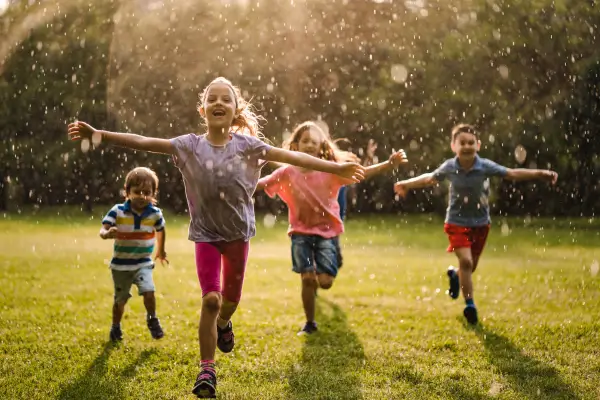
[{"x1": 198, "y1": 76, "x2": 264, "y2": 139}]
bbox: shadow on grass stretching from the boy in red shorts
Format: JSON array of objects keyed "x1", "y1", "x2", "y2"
[{"x1": 463, "y1": 320, "x2": 580, "y2": 400}]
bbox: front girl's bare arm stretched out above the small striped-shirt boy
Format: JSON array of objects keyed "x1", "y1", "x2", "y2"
[{"x1": 68, "y1": 121, "x2": 175, "y2": 154}]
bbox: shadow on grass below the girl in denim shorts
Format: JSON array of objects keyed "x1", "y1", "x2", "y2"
[{"x1": 287, "y1": 297, "x2": 365, "y2": 400}]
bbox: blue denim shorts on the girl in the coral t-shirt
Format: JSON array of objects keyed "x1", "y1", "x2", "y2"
[{"x1": 292, "y1": 234, "x2": 339, "y2": 277}]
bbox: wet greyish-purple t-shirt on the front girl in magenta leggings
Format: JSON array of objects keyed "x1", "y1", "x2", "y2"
[{"x1": 171, "y1": 133, "x2": 271, "y2": 242}]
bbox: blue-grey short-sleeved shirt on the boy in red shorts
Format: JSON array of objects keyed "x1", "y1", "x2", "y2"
[{"x1": 433, "y1": 156, "x2": 507, "y2": 227}]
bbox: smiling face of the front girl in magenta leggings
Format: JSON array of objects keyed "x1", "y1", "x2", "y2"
[{"x1": 199, "y1": 82, "x2": 236, "y2": 131}]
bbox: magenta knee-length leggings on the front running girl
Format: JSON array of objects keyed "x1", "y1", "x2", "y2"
[{"x1": 196, "y1": 239, "x2": 250, "y2": 303}]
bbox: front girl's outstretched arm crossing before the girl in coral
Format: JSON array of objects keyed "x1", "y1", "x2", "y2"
[{"x1": 263, "y1": 147, "x2": 365, "y2": 182}]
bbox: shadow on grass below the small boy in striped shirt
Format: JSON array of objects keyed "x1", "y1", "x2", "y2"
[{"x1": 56, "y1": 342, "x2": 156, "y2": 400}]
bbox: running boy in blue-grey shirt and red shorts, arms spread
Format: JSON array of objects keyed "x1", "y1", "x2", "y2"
[{"x1": 394, "y1": 124, "x2": 558, "y2": 324}]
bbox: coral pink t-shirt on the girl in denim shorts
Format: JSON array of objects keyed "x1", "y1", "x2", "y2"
[{"x1": 259, "y1": 165, "x2": 353, "y2": 239}]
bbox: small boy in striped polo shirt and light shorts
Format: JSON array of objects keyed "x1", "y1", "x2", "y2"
[{"x1": 100, "y1": 167, "x2": 168, "y2": 341}]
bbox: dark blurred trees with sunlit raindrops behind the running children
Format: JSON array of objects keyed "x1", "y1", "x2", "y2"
[{"x1": 0, "y1": 0, "x2": 600, "y2": 215}]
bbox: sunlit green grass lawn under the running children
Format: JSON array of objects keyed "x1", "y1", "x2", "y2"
[{"x1": 0, "y1": 209, "x2": 600, "y2": 400}]
